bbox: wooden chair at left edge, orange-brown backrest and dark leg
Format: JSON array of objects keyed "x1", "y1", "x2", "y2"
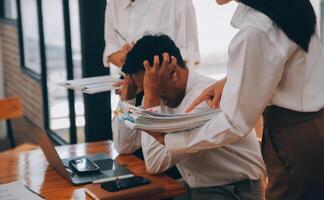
[{"x1": 0, "y1": 97, "x2": 23, "y2": 148}]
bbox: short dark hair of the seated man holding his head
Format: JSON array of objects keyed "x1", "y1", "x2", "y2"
[{"x1": 122, "y1": 34, "x2": 186, "y2": 74}]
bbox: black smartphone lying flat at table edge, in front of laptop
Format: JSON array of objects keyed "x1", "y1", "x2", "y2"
[{"x1": 101, "y1": 176, "x2": 151, "y2": 192}]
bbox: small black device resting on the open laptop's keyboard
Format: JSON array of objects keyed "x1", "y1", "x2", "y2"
[{"x1": 69, "y1": 158, "x2": 100, "y2": 175}]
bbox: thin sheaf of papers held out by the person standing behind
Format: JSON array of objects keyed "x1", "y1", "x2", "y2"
[{"x1": 59, "y1": 76, "x2": 120, "y2": 94}]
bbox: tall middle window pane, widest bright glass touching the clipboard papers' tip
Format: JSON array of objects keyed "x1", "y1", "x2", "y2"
[{"x1": 42, "y1": 0, "x2": 70, "y2": 142}]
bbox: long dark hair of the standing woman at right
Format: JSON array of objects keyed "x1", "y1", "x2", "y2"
[{"x1": 240, "y1": 0, "x2": 316, "y2": 52}]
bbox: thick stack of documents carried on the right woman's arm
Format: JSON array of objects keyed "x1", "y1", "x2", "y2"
[{"x1": 115, "y1": 102, "x2": 220, "y2": 133}]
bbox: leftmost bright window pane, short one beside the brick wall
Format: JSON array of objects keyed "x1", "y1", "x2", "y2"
[{"x1": 20, "y1": 0, "x2": 41, "y2": 76}]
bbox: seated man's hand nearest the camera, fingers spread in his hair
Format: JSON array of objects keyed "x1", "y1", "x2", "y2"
[{"x1": 143, "y1": 53, "x2": 177, "y2": 109}]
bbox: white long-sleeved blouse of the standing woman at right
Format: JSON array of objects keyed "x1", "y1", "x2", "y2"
[{"x1": 165, "y1": 3, "x2": 324, "y2": 152}]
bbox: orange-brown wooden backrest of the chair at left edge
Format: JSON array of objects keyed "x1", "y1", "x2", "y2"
[{"x1": 0, "y1": 97, "x2": 23, "y2": 120}]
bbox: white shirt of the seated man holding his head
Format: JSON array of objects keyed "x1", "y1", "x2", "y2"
[{"x1": 113, "y1": 71, "x2": 266, "y2": 188}]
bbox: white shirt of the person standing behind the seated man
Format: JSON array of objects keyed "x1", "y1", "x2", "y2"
[{"x1": 103, "y1": 0, "x2": 200, "y2": 66}]
